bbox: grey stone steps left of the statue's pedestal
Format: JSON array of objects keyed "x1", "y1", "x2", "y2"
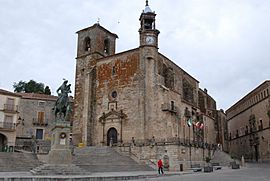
[{"x1": 0, "y1": 152, "x2": 41, "y2": 172}]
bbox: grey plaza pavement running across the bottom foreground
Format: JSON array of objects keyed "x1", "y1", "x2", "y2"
[{"x1": 0, "y1": 164, "x2": 270, "y2": 181}]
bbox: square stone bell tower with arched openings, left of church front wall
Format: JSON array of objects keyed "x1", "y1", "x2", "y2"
[{"x1": 72, "y1": 23, "x2": 118, "y2": 145}]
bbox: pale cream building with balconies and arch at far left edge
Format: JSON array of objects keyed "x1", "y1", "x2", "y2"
[{"x1": 0, "y1": 89, "x2": 21, "y2": 152}]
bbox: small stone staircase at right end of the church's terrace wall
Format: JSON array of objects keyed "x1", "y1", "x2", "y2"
[{"x1": 211, "y1": 150, "x2": 239, "y2": 166}]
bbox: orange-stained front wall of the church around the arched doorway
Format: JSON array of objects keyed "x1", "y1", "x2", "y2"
[{"x1": 94, "y1": 51, "x2": 143, "y2": 145}]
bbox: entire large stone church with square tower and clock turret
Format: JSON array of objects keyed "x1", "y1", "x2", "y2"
[{"x1": 73, "y1": 3, "x2": 220, "y2": 168}]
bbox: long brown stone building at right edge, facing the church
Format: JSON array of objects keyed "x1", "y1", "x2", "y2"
[{"x1": 226, "y1": 80, "x2": 270, "y2": 161}]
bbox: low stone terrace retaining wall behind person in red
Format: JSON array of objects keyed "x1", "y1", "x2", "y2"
[{"x1": 116, "y1": 138, "x2": 217, "y2": 171}]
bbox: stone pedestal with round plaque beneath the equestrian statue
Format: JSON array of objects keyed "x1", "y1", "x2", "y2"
[{"x1": 48, "y1": 121, "x2": 72, "y2": 164}]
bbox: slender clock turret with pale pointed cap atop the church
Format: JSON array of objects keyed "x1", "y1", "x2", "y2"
[{"x1": 139, "y1": 0, "x2": 159, "y2": 48}]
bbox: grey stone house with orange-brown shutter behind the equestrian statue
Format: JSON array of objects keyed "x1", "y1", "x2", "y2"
[{"x1": 16, "y1": 93, "x2": 73, "y2": 153}]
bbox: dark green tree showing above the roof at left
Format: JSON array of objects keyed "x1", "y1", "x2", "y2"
[{"x1": 13, "y1": 80, "x2": 51, "y2": 95}]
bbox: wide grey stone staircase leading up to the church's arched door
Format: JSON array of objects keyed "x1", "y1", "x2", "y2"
[{"x1": 73, "y1": 147, "x2": 153, "y2": 172}]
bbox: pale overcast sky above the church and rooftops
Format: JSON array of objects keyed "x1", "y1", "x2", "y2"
[{"x1": 0, "y1": 0, "x2": 270, "y2": 110}]
